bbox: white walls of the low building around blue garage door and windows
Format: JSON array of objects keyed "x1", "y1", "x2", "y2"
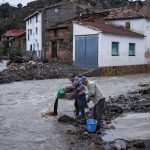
[{"x1": 73, "y1": 23, "x2": 146, "y2": 67}]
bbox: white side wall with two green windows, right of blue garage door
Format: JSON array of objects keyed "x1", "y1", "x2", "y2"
[{"x1": 98, "y1": 33, "x2": 146, "y2": 67}]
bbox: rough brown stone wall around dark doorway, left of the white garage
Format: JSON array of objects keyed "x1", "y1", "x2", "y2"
[{"x1": 46, "y1": 28, "x2": 72, "y2": 62}]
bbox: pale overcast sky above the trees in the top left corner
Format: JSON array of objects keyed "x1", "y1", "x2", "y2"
[{"x1": 0, "y1": 0, "x2": 34, "y2": 6}]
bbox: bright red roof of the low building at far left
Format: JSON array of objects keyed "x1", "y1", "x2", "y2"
[{"x1": 4, "y1": 29, "x2": 26, "y2": 37}]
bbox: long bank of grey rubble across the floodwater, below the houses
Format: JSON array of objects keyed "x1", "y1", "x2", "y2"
[{"x1": 0, "y1": 61, "x2": 84, "y2": 84}]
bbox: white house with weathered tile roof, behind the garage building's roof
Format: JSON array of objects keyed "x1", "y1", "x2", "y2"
[{"x1": 105, "y1": 8, "x2": 150, "y2": 55}]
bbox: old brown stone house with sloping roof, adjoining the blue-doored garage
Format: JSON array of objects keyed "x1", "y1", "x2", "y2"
[{"x1": 46, "y1": 19, "x2": 73, "y2": 62}]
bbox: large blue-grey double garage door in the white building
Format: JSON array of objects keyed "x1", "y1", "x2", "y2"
[{"x1": 75, "y1": 35, "x2": 98, "y2": 68}]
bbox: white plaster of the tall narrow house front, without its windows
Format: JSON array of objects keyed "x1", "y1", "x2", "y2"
[{"x1": 26, "y1": 13, "x2": 42, "y2": 57}]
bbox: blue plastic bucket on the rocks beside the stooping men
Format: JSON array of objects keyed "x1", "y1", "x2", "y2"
[{"x1": 86, "y1": 119, "x2": 97, "y2": 133}]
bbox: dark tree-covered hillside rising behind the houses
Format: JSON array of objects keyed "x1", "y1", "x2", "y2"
[{"x1": 0, "y1": 0, "x2": 131, "y2": 35}]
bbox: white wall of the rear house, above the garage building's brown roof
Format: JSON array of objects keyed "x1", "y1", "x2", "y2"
[{"x1": 107, "y1": 18, "x2": 150, "y2": 52}]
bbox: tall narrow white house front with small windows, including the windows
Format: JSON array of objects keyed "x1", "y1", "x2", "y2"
[{"x1": 25, "y1": 11, "x2": 42, "y2": 58}]
